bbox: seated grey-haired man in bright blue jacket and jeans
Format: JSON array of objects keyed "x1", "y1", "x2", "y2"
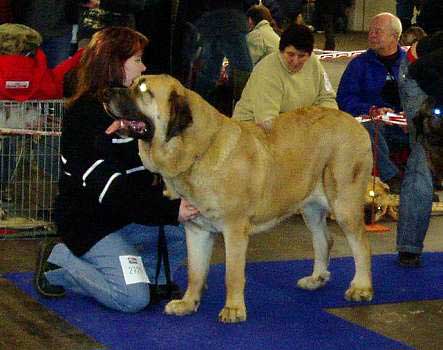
[{"x1": 337, "y1": 12, "x2": 409, "y2": 193}]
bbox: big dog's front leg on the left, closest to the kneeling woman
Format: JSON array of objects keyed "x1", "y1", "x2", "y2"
[{"x1": 165, "y1": 223, "x2": 214, "y2": 316}]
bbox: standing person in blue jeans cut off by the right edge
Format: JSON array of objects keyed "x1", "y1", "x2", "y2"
[{"x1": 397, "y1": 32, "x2": 443, "y2": 267}]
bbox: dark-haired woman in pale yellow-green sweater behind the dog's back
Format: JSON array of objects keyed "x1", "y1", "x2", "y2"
[{"x1": 233, "y1": 25, "x2": 337, "y2": 128}]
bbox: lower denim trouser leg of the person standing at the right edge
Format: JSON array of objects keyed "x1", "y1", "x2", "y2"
[{"x1": 397, "y1": 143, "x2": 433, "y2": 254}]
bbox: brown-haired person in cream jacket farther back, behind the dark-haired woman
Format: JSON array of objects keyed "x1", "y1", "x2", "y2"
[{"x1": 246, "y1": 5, "x2": 280, "y2": 66}]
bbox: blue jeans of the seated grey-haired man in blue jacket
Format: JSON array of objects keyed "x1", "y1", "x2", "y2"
[{"x1": 363, "y1": 122, "x2": 409, "y2": 182}]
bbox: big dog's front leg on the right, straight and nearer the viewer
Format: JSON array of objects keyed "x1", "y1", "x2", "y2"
[{"x1": 218, "y1": 223, "x2": 249, "y2": 323}]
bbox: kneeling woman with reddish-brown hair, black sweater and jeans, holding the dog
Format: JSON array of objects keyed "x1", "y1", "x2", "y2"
[{"x1": 36, "y1": 27, "x2": 198, "y2": 312}]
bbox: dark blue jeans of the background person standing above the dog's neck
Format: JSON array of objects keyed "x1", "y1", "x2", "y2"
[{"x1": 194, "y1": 33, "x2": 252, "y2": 104}]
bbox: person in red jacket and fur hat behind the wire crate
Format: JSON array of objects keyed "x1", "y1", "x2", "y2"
[{"x1": 0, "y1": 23, "x2": 82, "y2": 193}]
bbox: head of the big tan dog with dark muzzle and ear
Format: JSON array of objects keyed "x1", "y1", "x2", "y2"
[{"x1": 104, "y1": 75, "x2": 192, "y2": 142}]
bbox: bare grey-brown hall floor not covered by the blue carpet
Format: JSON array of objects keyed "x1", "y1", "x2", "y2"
[{"x1": 0, "y1": 33, "x2": 443, "y2": 350}]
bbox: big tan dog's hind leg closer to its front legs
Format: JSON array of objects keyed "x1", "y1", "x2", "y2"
[{"x1": 297, "y1": 202, "x2": 333, "y2": 290}]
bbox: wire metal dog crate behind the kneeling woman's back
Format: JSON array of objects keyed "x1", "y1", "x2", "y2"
[{"x1": 0, "y1": 100, "x2": 63, "y2": 232}]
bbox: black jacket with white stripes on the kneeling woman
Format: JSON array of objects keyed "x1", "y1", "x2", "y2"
[{"x1": 55, "y1": 97, "x2": 180, "y2": 256}]
